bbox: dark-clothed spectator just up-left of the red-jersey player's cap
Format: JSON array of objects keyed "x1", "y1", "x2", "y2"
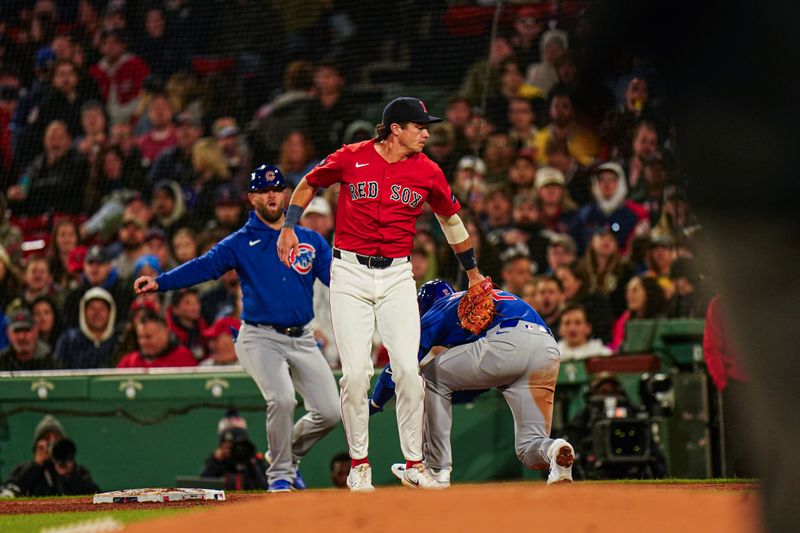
[{"x1": 308, "y1": 60, "x2": 358, "y2": 156}]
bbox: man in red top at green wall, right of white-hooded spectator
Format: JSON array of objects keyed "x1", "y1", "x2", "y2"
[{"x1": 117, "y1": 312, "x2": 197, "y2": 368}]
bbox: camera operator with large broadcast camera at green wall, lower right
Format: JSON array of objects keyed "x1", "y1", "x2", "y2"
[{"x1": 567, "y1": 372, "x2": 666, "y2": 479}]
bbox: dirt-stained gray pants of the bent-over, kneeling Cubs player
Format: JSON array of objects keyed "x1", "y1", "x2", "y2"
[{"x1": 422, "y1": 321, "x2": 560, "y2": 470}]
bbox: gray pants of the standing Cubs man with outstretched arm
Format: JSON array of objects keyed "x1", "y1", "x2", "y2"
[{"x1": 236, "y1": 323, "x2": 341, "y2": 483}]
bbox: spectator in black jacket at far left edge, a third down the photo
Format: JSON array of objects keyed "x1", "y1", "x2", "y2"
[{"x1": 8, "y1": 120, "x2": 89, "y2": 215}]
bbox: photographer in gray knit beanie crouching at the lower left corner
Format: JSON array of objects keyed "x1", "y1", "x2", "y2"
[{"x1": 2, "y1": 415, "x2": 100, "y2": 497}]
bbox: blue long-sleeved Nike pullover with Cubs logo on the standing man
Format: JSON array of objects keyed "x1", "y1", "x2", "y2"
[{"x1": 156, "y1": 212, "x2": 331, "y2": 327}]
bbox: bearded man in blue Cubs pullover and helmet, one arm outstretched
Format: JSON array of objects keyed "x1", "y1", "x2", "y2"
[{"x1": 134, "y1": 165, "x2": 340, "y2": 492}]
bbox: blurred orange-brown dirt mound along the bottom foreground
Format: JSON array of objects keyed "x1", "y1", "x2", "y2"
[{"x1": 111, "y1": 483, "x2": 760, "y2": 533}]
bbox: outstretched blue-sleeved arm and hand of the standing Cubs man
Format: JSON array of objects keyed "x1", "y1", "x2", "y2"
[{"x1": 133, "y1": 238, "x2": 237, "y2": 294}]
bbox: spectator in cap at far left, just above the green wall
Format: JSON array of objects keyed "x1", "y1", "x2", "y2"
[{"x1": 0, "y1": 308, "x2": 58, "y2": 372}]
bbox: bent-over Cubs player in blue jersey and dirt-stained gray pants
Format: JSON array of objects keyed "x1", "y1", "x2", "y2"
[{"x1": 370, "y1": 280, "x2": 574, "y2": 487}]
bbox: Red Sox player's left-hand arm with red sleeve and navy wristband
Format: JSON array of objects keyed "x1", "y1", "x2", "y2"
[{"x1": 278, "y1": 146, "x2": 349, "y2": 268}]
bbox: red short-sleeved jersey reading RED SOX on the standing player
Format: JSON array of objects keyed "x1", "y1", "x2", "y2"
[{"x1": 306, "y1": 139, "x2": 461, "y2": 258}]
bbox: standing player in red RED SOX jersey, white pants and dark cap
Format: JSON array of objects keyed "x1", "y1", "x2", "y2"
[{"x1": 278, "y1": 97, "x2": 483, "y2": 491}]
